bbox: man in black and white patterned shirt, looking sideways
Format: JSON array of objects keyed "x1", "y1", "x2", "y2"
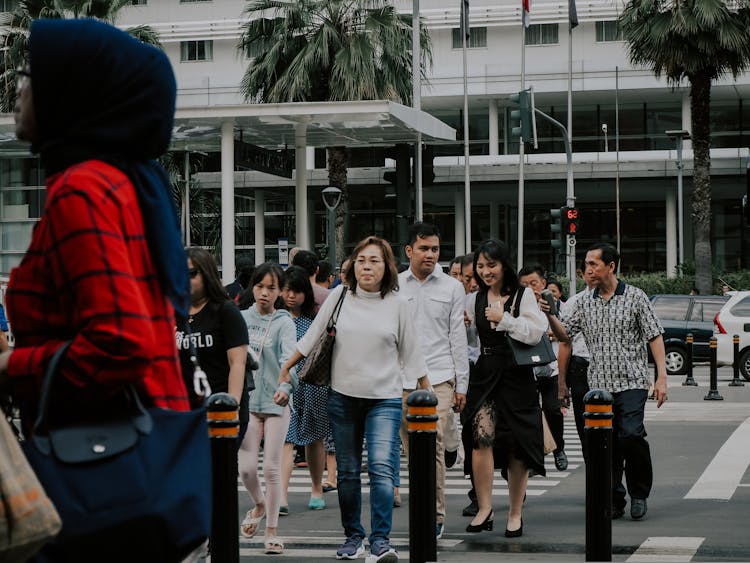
[{"x1": 542, "y1": 243, "x2": 667, "y2": 520}]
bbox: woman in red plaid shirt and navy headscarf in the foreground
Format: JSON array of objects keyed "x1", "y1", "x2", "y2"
[{"x1": 0, "y1": 20, "x2": 190, "y2": 425}]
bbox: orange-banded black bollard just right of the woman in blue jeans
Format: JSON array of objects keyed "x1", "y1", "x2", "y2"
[{"x1": 406, "y1": 389, "x2": 438, "y2": 563}]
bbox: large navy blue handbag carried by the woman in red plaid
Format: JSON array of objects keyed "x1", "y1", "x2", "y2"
[{"x1": 24, "y1": 342, "x2": 211, "y2": 563}]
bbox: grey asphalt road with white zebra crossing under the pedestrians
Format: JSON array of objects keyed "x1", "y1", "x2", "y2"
[{"x1": 232, "y1": 366, "x2": 750, "y2": 563}]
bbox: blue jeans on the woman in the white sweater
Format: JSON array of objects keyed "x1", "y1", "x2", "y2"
[{"x1": 328, "y1": 389, "x2": 401, "y2": 545}]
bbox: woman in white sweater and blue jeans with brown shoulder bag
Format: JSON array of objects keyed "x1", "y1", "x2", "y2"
[{"x1": 280, "y1": 236, "x2": 429, "y2": 563}]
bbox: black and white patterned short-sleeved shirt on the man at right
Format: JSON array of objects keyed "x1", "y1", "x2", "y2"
[{"x1": 562, "y1": 281, "x2": 664, "y2": 393}]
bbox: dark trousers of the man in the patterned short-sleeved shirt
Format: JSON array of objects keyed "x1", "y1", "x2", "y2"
[{"x1": 612, "y1": 389, "x2": 654, "y2": 508}]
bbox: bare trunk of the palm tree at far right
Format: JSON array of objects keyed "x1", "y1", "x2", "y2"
[{"x1": 689, "y1": 73, "x2": 713, "y2": 295}]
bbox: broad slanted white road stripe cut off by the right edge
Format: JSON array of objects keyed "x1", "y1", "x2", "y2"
[{"x1": 685, "y1": 418, "x2": 750, "y2": 500}]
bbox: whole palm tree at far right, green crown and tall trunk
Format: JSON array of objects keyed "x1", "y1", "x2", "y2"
[{"x1": 619, "y1": 0, "x2": 750, "y2": 294}]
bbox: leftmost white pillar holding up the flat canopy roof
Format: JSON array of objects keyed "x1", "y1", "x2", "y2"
[{"x1": 221, "y1": 119, "x2": 235, "y2": 285}]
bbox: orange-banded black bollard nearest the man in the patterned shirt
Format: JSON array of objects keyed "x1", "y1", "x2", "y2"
[{"x1": 583, "y1": 389, "x2": 613, "y2": 561}]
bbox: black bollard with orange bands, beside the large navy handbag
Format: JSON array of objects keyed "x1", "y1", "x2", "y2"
[{"x1": 207, "y1": 393, "x2": 240, "y2": 563}]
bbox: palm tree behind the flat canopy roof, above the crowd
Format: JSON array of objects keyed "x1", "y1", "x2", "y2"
[{"x1": 238, "y1": 0, "x2": 432, "y2": 261}]
